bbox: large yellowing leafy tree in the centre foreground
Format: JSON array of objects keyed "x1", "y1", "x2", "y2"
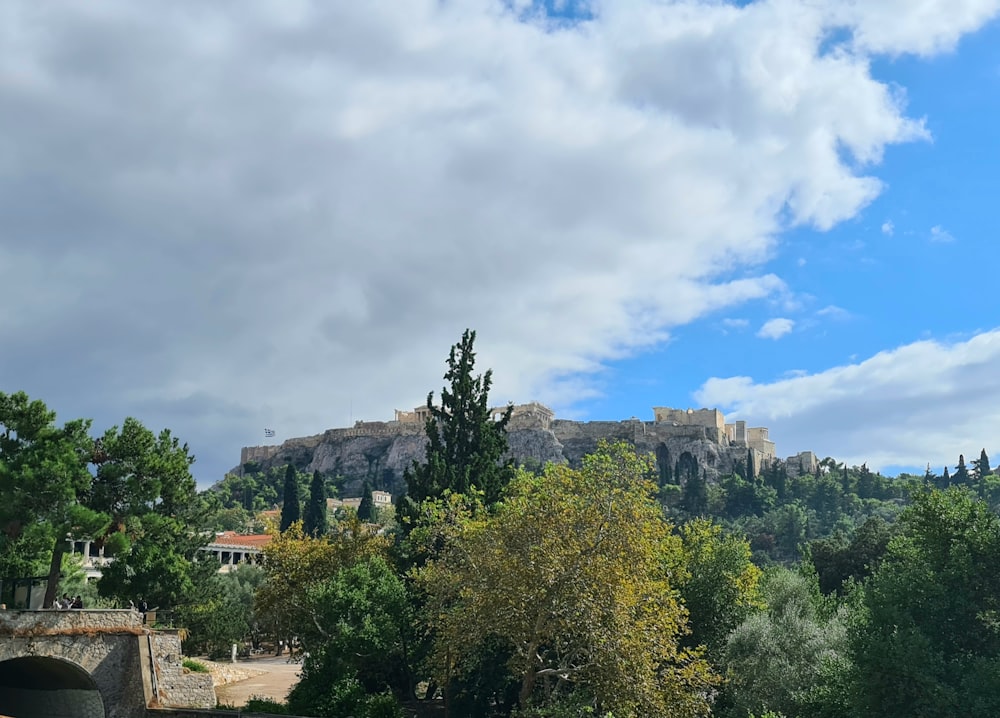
[{"x1": 419, "y1": 444, "x2": 714, "y2": 718}]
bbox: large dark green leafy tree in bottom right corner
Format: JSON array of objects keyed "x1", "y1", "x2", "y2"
[{"x1": 851, "y1": 487, "x2": 1000, "y2": 718}]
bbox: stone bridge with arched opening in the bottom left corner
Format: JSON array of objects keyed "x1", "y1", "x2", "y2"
[{"x1": 0, "y1": 610, "x2": 215, "y2": 718}]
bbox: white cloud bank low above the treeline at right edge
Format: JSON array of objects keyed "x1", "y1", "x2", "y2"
[{"x1": 696, "y1": 329, "x2": 1000, "y2": 472}]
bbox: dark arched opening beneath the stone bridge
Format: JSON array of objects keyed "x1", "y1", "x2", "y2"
[{"x1": 0, "y1": 656, "x2": 107, "y2": 718}]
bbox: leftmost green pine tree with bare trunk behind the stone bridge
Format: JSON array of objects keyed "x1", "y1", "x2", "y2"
[{"x1": 0, "y1": 392, "x2": 110, "y2": 607}]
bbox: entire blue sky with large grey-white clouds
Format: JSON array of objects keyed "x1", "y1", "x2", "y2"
[{"x1": 0, "y1": 0, "x2": 1000, "y2": 487}]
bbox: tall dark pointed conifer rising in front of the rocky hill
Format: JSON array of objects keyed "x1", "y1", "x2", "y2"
[{"x1": 396, "y1": 329, "x2": 514, "y2": 532}]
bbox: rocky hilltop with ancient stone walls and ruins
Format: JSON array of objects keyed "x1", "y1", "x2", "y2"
[{"x1": 234, "y1": 402, "x2": 817, "y2": 496}]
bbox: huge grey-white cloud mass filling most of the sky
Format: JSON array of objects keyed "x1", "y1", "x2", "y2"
[{"x1": 0, "y1": 0, "x2": 995, "y2": 481}]
